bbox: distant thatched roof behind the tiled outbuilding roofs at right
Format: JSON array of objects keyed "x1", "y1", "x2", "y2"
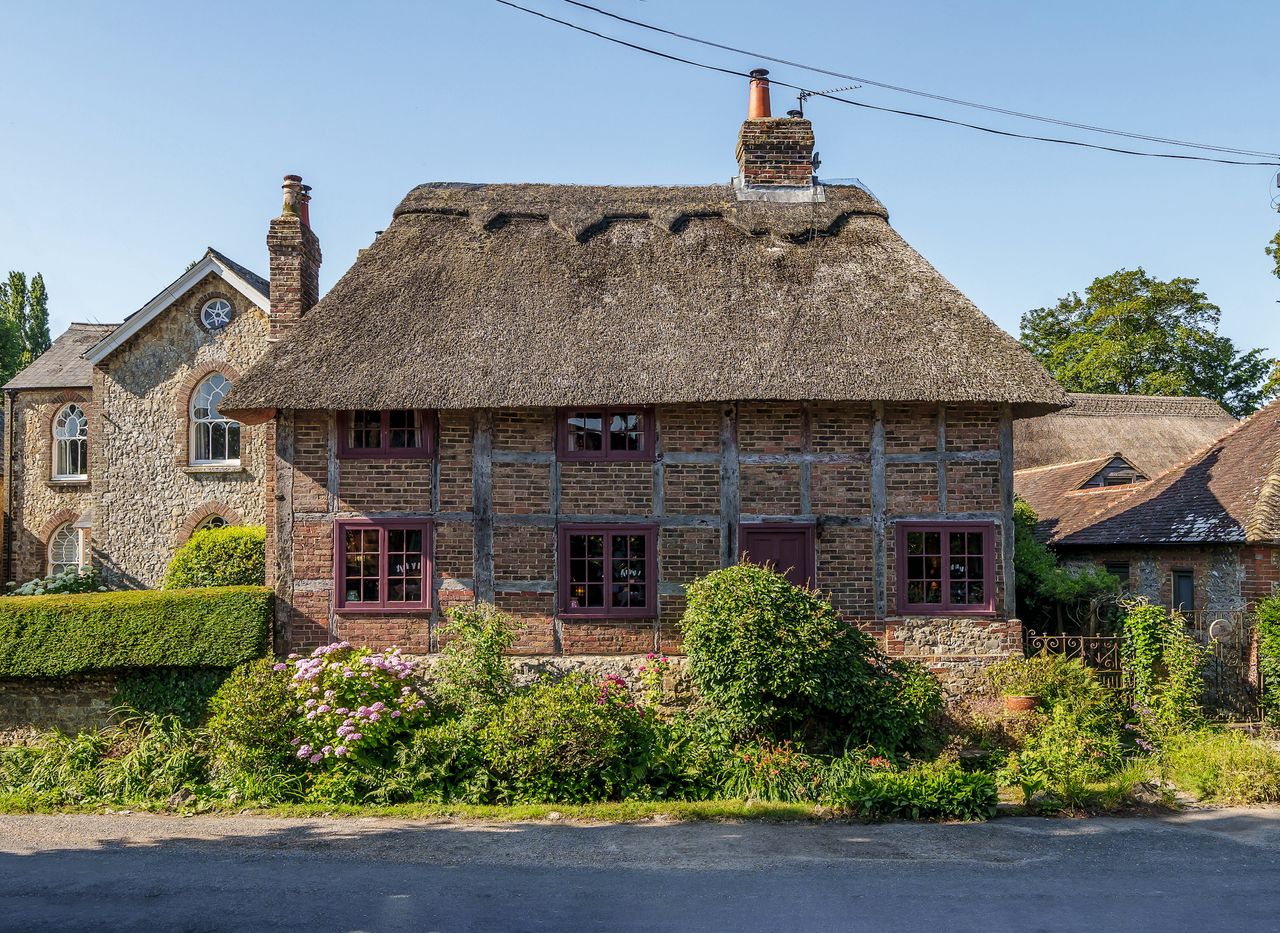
[{"x1": 1014, "y1": 393, "x2": 1235, "y2": 476}]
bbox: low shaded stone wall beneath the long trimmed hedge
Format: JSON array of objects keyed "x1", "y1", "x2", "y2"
[{"x1": 0, "y1": 674, "x2": 116, "y2": 735}]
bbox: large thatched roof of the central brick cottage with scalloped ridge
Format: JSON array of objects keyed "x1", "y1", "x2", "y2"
[{"x1": 223, "y1": 184, "x2": 1065, "y2": 415}]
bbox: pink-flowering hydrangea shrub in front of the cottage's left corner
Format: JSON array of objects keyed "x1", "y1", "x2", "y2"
[{"x1": 275, "y1": 641, "x2": 426, "y2": 765}]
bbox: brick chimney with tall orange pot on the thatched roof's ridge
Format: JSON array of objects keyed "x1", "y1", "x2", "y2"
[{"x1": 737, "y1": 68, "x2": 813, "y2": 188}]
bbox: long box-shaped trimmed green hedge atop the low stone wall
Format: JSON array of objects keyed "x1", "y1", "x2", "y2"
[{"x1": 0, "y1": 586, "x2": 271, "y2": 677}]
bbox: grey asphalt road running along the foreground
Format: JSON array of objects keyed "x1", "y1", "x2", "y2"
[{"x1": 0, "y1": 810, "x2": 1280, "y2": 933}]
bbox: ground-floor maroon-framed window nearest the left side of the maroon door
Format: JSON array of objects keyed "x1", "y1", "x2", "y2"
[{"x1": 559, "y1": 525, "x2": 658, "y2": 618}]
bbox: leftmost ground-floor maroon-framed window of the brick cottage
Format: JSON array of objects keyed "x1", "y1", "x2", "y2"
[{"x1": 333, "y1": 518, "x2": 431, "y2": 612}]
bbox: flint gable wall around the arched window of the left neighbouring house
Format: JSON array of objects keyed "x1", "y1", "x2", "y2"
[{"x1": 90, "y1": 274, "x2": 269, "y2": 586}]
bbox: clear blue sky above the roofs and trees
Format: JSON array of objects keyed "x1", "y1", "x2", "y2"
[{"x1": 0, "y1": 0, "x2": 1280, "y2": 355}]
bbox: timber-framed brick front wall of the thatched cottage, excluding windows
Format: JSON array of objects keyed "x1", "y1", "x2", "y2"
[{"x1": 276, "y1": 403, "x2": 1020, "y2": 676}]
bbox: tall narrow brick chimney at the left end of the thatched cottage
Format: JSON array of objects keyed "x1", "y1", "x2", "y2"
[{"x1": 266, "y1": 175, "x2": 320, "y2": 340}]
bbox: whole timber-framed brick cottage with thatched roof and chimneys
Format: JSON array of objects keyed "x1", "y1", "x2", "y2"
[{"x1": 224, "y1": 76, "x2": 1066, "y2": 674}]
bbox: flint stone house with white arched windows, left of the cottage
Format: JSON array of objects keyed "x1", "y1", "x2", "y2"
[{"x1": 4, "y1": 250, "x2": 270, "y2": 586}]
